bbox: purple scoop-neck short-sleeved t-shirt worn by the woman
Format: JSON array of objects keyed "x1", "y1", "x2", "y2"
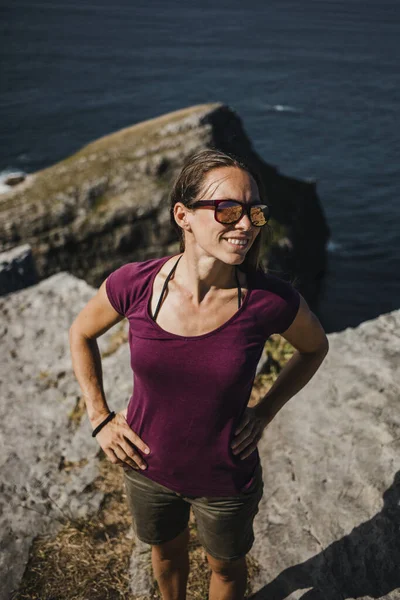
[{"x1": 106, "y1": 256, "x2": 300, "y2": 497}]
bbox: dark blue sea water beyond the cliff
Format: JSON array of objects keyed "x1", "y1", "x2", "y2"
[{"x1": 0, "y1": 0, "x2": 400, "y2": 331}]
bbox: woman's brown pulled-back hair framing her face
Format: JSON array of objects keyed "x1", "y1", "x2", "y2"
[{"x1": 170, "y1": 150, "x2": 268, "y2": 271}]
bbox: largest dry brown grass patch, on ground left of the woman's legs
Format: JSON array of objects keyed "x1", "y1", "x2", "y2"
[{"x1": 12, "y1": 459, "x2": 134, "y2": 600}]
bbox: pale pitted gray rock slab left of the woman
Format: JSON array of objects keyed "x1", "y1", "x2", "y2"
[{"x1": 0, "y1": 273, "x2": 132, "y2": 600}]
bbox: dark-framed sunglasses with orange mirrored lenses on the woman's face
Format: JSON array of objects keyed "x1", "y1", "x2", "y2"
[{"x1": 188, "y1": 200, "x2": 270, "y2": 227}]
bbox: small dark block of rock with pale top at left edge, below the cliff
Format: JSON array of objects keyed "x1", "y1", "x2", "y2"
[{"x1": 0, "y1": 244, "x2": 38, "y2": 296}]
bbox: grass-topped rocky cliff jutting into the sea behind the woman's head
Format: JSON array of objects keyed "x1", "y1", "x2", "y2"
[{"x1": 0, "y1": 104, "x2": 329, "y2": 302}]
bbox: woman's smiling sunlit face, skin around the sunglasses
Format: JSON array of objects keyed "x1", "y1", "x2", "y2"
[{"x1": 186, "y1": 167, "x2": 260, "y2": 265}]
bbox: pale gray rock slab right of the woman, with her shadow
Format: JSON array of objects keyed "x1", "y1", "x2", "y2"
[{"x1": 252, "y1": 310, "x2": 400, "y2": 600}]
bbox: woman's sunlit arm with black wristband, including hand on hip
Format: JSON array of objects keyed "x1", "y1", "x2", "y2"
[{"x1": 69, "y1": 282, "x2": 147, "y2": 468}]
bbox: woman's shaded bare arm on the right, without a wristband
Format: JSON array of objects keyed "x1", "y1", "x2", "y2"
[{"x1": 232, "y1": 295, "x2": 329, "y2": 459}]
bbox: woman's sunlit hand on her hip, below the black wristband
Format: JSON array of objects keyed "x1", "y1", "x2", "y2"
[{"x1": 95, "y1": 409, "x2": 150, "y2": 470}]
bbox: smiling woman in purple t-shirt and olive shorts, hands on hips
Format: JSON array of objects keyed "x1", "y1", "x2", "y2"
[{"x1": 70, "y1": 150, "x2": 328, "y2": 600}]
